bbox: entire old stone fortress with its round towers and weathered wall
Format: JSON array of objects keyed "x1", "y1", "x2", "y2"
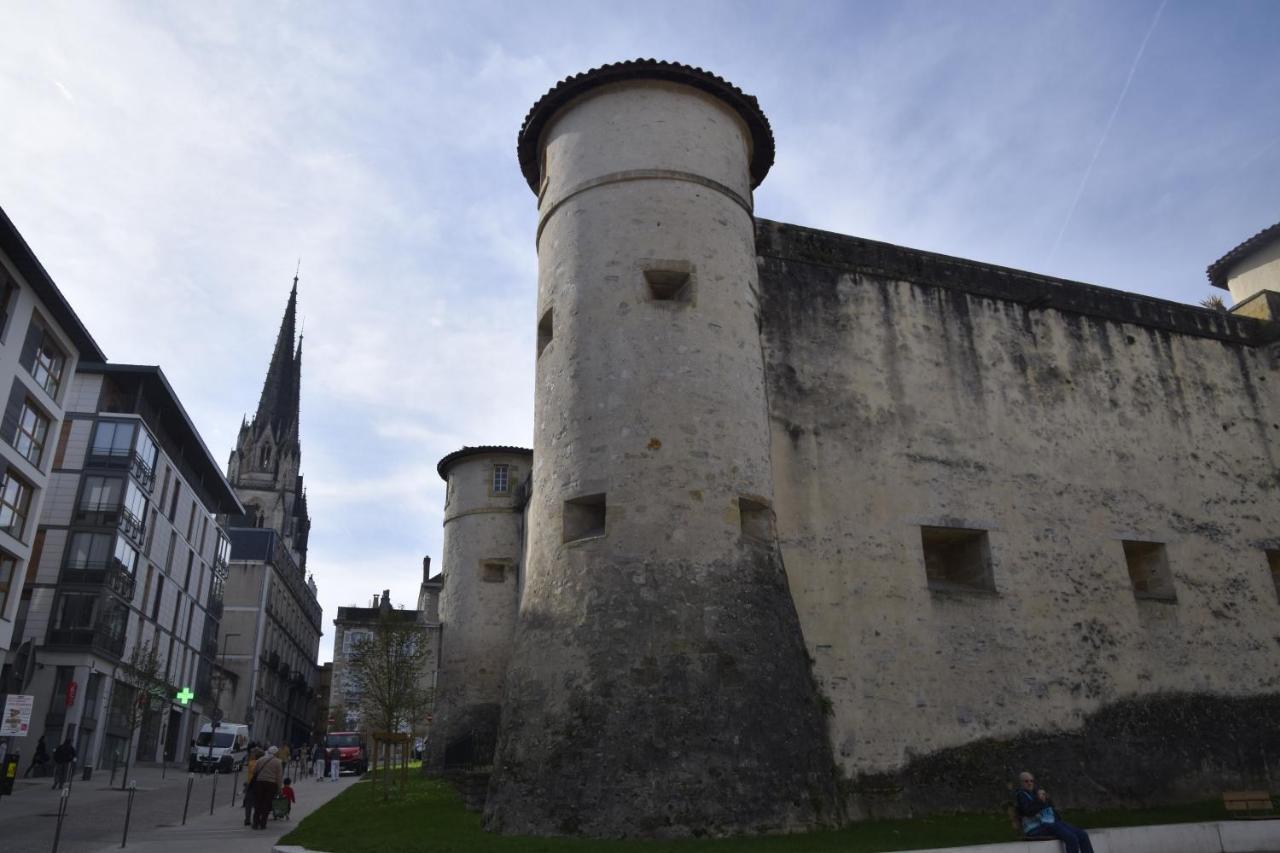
[{"x1": 431, "y1": 60, "x2": 1280, "y2": 836}]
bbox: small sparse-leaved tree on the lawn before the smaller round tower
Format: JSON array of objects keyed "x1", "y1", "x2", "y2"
[{"x1": 348, "y1": 610, "x2": 431, "y2": 731}]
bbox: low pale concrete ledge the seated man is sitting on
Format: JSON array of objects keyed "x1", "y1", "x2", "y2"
[{"x1": 904, "y1": 820, "x2": 1280, "y2": 853}]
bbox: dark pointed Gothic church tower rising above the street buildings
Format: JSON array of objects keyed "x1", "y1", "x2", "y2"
[{"x1": 227, "y1": 275, "x2": 311, "y2": 573}]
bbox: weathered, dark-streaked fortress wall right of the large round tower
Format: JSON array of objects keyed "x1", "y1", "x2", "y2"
[{"x1": 758, "y1": 222, "x2": 1280, "y2": 815}]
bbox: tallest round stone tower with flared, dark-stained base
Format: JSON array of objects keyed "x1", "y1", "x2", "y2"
[{"x1": 485, "y1": 60, "x2": 838, "y2": 836}]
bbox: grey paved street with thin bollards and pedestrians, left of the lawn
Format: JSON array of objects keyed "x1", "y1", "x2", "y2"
[{"x1": 0, "y1": 767, "x2": 357, "y2": 853}]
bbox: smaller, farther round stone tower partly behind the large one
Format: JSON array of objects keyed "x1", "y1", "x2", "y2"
[{"x1": 428, "y1": 447, "x2": 530, "y2": 770}]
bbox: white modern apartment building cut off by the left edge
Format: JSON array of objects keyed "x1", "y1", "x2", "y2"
[{"x1": 0, "y1": 202, "x2": 104, "y2": 693}]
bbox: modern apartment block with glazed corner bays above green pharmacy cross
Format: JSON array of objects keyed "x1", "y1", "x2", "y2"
[{"x1": 12, "y1": 362, "x2": 242, "y2": 766}]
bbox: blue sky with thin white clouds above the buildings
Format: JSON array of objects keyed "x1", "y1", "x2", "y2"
[{"x1": 0, "y1": 0, "x2": 1280, "y2": 661}]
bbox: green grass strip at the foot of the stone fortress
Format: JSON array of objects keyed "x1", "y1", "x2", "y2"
[{"x1": 279, "y1": 772, "x2": 1225, "y2": 853}]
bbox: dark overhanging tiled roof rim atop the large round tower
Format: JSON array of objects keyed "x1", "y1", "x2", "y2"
[{"x1": 516, "y1": 59, "x2": 773, "y2": 192}]
